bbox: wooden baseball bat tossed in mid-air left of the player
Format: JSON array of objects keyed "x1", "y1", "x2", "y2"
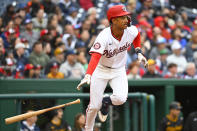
[{"x1": 5, "y1": 99, "x2": 80, "y2": 124}]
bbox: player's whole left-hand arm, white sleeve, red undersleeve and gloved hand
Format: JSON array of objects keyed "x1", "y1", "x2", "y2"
[{"x1": 77, "y1": 29, "x2": 106, "y2": 90}]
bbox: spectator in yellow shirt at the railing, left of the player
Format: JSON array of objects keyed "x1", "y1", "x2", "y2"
[{"x1": 47, "y1": 62, "x2": 64, "y2": 79}]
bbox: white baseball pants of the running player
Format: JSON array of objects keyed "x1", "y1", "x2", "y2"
[{"x1": 85, "y1": 65, "x2": 128, "y2": 131}]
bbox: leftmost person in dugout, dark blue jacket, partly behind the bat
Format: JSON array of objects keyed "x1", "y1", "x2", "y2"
[{"x1": 20, "y1": 110, "x2": 40, "y2": 131}]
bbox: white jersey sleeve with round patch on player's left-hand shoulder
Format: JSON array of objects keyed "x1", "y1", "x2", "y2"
[{"x1": 89, "y1": 31, "x2": 107, "y2": 55}]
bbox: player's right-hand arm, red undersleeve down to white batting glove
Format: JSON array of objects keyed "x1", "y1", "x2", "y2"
[{"x1": 133, "y1": 31, "x2": 148, "y2": 67}]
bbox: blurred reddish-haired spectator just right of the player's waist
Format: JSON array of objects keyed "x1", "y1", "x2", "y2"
[{"x1": 127, "y1": 61, "x2": 141, "y2": 79}]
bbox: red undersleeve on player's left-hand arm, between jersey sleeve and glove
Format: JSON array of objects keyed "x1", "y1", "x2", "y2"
[{"x1": 86, "y1": 53, "x2": 101, "y2": 75}]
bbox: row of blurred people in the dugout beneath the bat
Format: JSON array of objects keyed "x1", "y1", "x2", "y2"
[{"x1": 20, "y1": 108, "x2": 101, "y2": 131}]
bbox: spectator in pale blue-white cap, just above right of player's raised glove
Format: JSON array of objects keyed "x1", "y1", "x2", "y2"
[{"x1": 149, "y1": 37, "x2": 168, "y2": 59}]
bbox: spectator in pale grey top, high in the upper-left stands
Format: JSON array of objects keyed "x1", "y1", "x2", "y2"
[{"x1": 32, "y1": 9, "x2": 47, "y2": 32}]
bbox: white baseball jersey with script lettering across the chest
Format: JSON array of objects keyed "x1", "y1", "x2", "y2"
[{"x1": 90, "y1": 26, "x2": 138, "y2": 68}]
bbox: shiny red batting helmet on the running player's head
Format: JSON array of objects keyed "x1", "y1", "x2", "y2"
[{"x1": 107, "y1": 5, "x2": 131, "y2": 22}]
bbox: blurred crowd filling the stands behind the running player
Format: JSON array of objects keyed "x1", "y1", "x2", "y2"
[{"x1": 0, "y1": 0, "x2": 197, "y2": 79}]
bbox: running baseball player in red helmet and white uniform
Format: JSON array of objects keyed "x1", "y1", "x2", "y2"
[{"x1": 77, "y1": 5, "x2": 147, "y2": 131}]
